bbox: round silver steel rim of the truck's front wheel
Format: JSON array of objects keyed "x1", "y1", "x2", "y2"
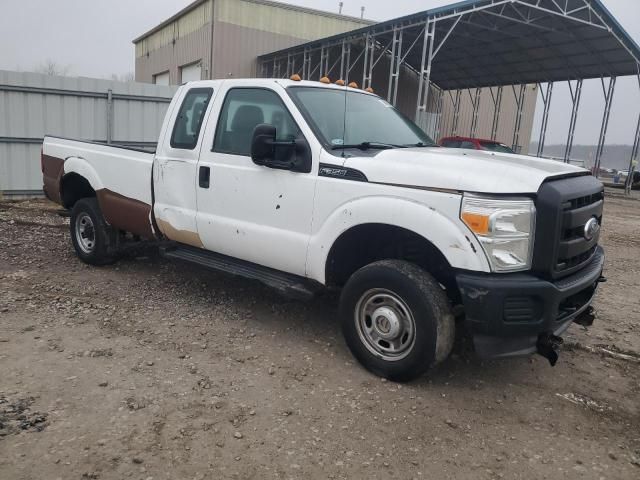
[{"x1": 355, "y1": 288, "x2": 416, "y2": 361}]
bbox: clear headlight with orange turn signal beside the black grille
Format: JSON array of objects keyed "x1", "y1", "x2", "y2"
[{"x1": 460, "y1": 195, "x2": 536, "y2": 272}]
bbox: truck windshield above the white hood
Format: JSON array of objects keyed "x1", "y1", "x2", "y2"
[{"x1": 287, "y1": 87, "x2": 435, "y2": 149}]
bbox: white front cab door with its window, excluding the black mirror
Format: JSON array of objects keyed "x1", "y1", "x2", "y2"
[{"x1": 196, "y1": 80, "x2": 320, "y2": 276}]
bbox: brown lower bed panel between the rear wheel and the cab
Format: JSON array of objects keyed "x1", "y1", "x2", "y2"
[{"x1": 96, "y1": 188, "x2": 155, "y2": 239}]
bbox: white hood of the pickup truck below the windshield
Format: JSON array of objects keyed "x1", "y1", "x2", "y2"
[{"x1": 344, "y1": 147, "x2": 587, "y2": 194}]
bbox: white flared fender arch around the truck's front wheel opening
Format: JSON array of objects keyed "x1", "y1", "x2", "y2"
[{"x1": 307, "y1": 196, "x2": 490, "y2": 283}]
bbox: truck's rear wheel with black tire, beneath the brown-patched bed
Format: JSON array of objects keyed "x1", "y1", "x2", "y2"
[{"x1": 69, "y1": 198, "x2": 118, "y2": 265}]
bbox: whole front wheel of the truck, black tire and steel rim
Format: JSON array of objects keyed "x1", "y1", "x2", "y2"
[{"x1": 340, "y1": 260, "x2": 455, "y2": 382}]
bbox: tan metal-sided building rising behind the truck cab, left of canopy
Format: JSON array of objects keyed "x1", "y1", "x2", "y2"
[{"x1": 133, "y1": 0, "x2": 372, "y2": 85}]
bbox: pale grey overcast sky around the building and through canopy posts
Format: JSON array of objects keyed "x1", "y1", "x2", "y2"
[{"x1": 0, "y1": 0, "x2": 640, "y2": 143}]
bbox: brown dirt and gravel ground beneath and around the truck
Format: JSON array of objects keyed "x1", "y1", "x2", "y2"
[{"x1": 0, "y1": 192, "x2": 640, "y2": 480}]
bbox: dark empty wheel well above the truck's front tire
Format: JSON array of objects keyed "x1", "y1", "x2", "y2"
[{"x1": 325, "y1": 223, "x2": 457, "y2": 296}]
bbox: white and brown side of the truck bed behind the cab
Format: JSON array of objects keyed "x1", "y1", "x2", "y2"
[{"x1": 42, "y1": 136, "x2": 154, "y2": 237}]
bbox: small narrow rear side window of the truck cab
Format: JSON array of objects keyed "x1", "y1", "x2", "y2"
[{"x1": 171, "y1": 88, "x2": 213, "y2": 150}]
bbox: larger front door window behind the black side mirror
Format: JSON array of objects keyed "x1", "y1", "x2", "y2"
[{"x1": 213, "y1": 88, "x2": 300, "y2": 157}]
